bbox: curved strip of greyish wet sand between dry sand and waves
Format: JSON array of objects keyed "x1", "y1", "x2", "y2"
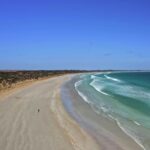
[{"x1": 62, "y1": 78, "x2": 143, "y2": 150}]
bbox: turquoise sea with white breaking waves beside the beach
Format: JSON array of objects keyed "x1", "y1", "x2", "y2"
[{"x1": 75, "y1": 72, "x2": 150, "y2": 150}]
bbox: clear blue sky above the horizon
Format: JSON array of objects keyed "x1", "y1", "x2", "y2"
[{"x1": 0, "y1": 0, "x2": 150, "y2": 70}]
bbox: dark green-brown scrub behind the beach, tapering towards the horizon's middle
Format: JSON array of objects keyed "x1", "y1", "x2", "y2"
[{"x1": 0, "y1": 70, "x2": 85, "y2": 90}]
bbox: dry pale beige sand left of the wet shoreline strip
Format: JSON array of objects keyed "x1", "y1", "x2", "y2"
[{"x1": 0, "y1": 76, "x2": 100, "y2": 150}]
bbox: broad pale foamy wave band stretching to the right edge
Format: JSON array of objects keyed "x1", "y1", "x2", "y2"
[{"x1": 92, "y1": 78, "x2": 150, "y2": 105}]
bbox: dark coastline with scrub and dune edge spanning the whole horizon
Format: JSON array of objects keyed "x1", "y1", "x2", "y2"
[{"x1": 0, "y1": 69, "x2": 150, "y2": 92}]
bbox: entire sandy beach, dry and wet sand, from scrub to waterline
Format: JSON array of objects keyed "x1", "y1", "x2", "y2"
[{"x1": 0, "y1": 75, "x2": 145, "y2": 150}]
